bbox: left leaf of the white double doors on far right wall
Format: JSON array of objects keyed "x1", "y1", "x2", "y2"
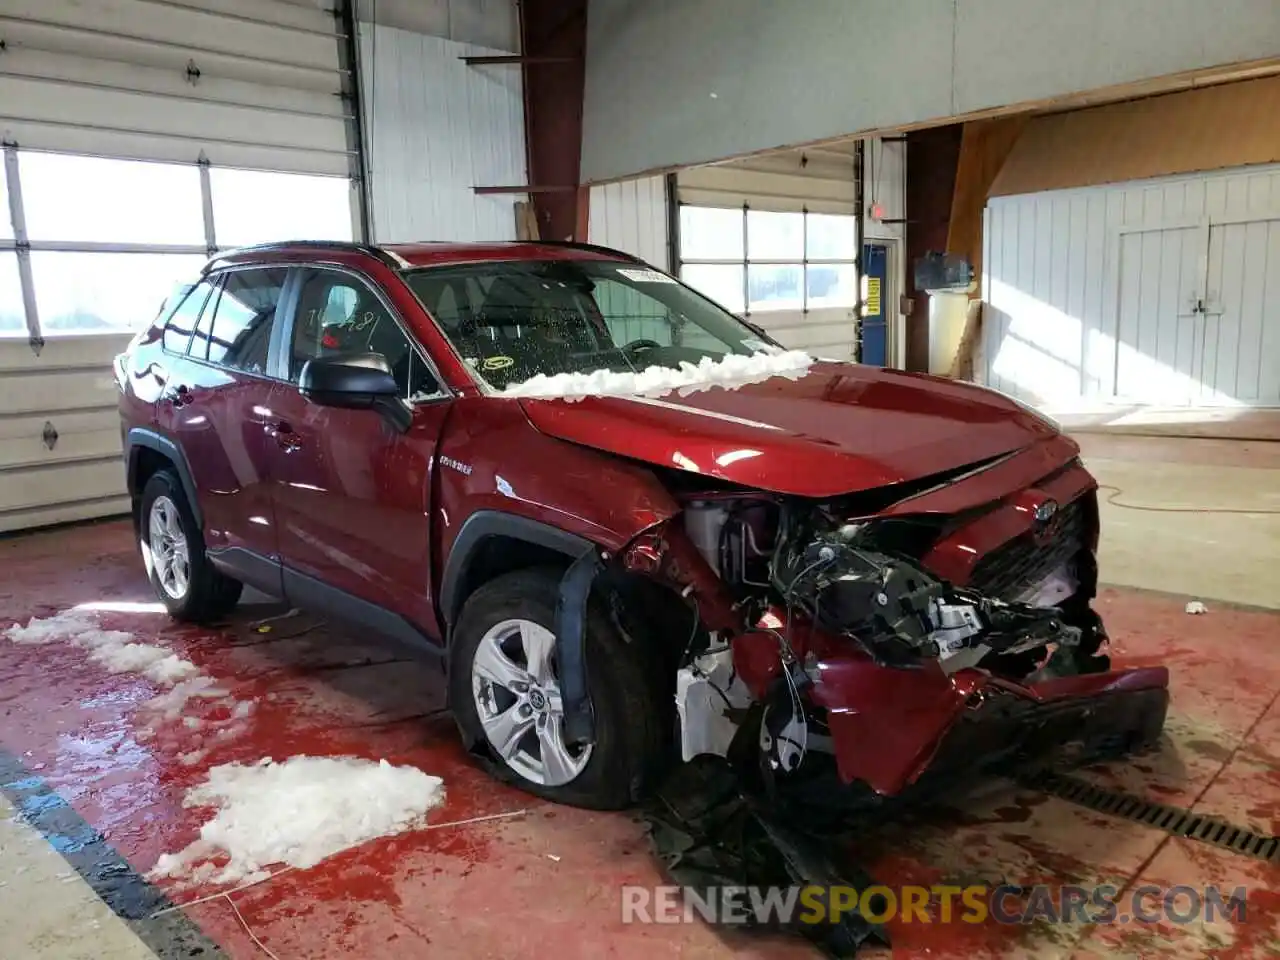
[{"x1": 1115, "y1": 227, "x2": 1206, "y2": 404}]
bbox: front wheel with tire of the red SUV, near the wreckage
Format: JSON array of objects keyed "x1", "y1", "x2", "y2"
[{"x1": 449, "y1": 568, "x2": 673, "y2": 810}]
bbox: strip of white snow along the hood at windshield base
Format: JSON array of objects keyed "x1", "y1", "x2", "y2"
[{"x1": 499, "y1": 349, "x2": 817, "y2": 401}]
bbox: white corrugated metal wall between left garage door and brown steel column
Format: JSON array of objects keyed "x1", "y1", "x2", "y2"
[{"x1": 361, "y1": 24, "x2": 527, "y2": 242}]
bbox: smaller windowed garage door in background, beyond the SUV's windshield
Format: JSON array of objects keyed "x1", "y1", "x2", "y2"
[{"x1": 677, "y1": 145, "x2": 858, "y2": 360}]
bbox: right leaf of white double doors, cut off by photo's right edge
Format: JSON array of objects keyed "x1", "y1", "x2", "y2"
[{"x1": 1198, "y1": 219, "x2": 1280, "y2": 407}]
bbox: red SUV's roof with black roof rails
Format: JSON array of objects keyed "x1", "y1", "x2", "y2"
[{"x1": 205, "y1": 241, "x2": 640, "y2": 270}]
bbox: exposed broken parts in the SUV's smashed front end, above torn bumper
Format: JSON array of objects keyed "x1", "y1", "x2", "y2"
[{"x1": 660, "y1": 497, "x2": 1110, "y2": 772}]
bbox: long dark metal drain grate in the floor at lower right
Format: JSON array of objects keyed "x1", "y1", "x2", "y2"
[{"x1": 1018, "y1": 771, "x2": 1280, "y2": 863}]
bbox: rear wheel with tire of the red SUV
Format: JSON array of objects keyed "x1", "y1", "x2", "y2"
[{"x1": 140, "y1": 470, "x2": 244, "y2": 623}]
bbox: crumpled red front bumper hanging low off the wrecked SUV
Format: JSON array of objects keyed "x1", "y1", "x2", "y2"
[{"x1": 809, "y1": 654, "x2": 1169, "y2": 796}]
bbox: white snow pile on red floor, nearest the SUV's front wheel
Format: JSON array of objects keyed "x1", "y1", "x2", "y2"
[{"x1": 151, "y1": 756, "x2": 444, "y2": 883}]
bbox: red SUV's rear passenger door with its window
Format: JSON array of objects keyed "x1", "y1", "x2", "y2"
[{"x1": 161, "y1": 266, "x2": 288, "y2": 591}]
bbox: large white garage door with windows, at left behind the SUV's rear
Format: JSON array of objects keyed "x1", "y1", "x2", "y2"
[{"x1": 0, "y1": 0, "x2": 358, "y2": 531}]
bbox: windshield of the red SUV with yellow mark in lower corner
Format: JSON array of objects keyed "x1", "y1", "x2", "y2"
[{"x1": 404, "y1": 260, "x2": 777, "y2": 390}]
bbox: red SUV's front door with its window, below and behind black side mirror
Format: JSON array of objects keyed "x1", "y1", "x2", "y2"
[{"x1": 268, "y1": 268, "x2": 451, "y2": 636}]
